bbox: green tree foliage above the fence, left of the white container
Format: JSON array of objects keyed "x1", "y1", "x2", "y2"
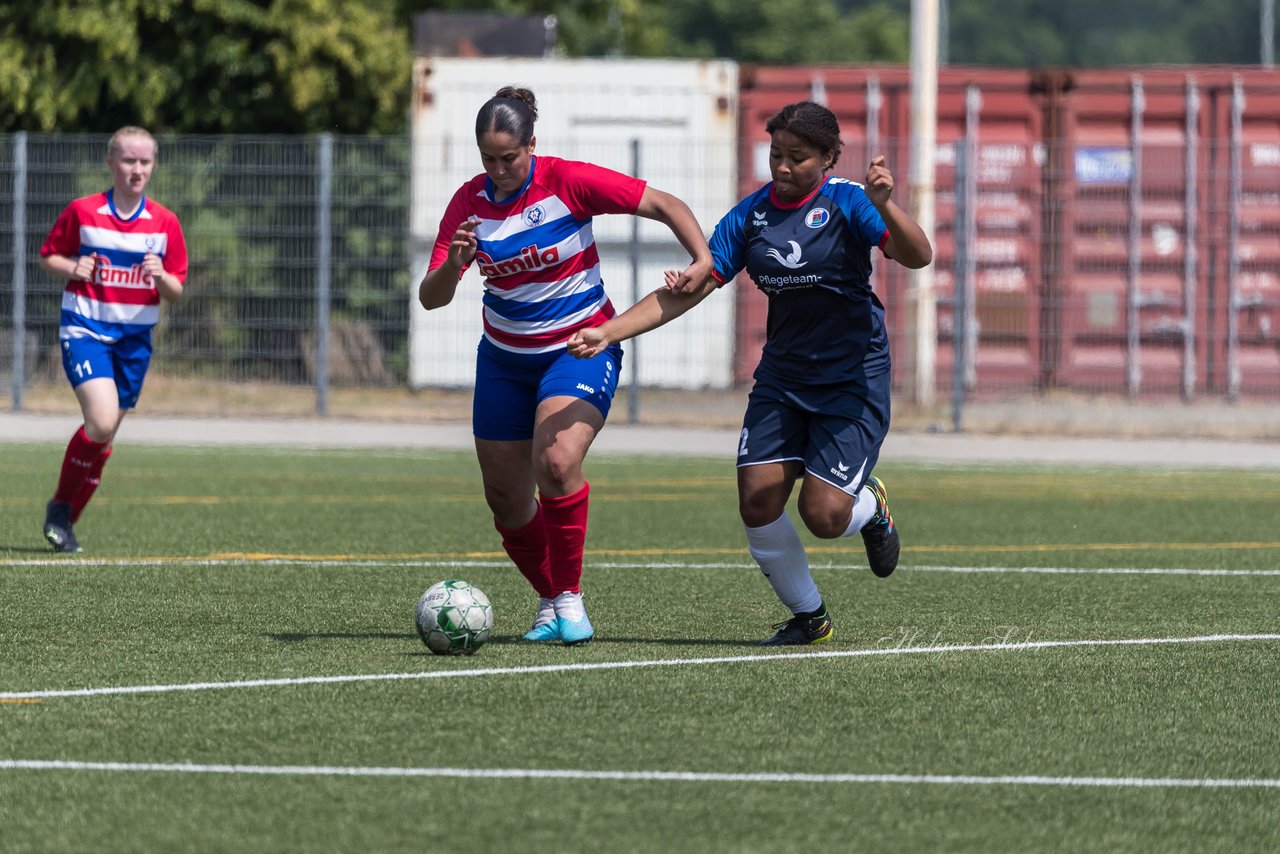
[{"x1": 0, "y1": 0, "x2": 412, "y2": 133}]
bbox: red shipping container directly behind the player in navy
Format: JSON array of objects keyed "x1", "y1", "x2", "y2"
[{"x1": 735, "y1": 67, "x2": 1042, "y2": 385}]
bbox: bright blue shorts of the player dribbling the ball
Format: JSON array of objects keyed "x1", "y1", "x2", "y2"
[{"x1": 471, "y1": 339, "x2": 622, "y2": 442}]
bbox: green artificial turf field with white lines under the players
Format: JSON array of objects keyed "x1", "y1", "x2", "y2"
[{"x1": 0, "y1": 443, "x2": 1280, "y2": 854}]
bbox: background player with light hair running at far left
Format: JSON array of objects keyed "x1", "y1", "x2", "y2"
[{"x1": 40, "y1": 127, "x2": 187, "y2": 552}]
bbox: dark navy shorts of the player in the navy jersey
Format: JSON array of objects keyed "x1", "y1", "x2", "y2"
[{"x1": 737, "y1": 371, "x2": 890, "y2": 495}]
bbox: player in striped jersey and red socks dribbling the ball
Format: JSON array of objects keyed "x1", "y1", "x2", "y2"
[{"x1": 419, "y1": 86, "x2": 712, "y2": 645}]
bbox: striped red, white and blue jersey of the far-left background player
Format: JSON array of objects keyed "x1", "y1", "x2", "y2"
[{"x1": 40, "y1": 189, "x2": 187, "y2": 343}]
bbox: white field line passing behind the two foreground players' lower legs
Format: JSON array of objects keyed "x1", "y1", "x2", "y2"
[{"x1": 0, "y1": 557, "x2": 1280, "y2": 577}]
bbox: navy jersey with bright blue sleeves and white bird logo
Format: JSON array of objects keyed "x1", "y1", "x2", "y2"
[{"x1": 710, "y1": 178, "x2": 890, "y2": 385}]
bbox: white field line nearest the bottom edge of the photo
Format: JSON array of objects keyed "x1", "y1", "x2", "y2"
[{"x1": 0, "y1": 759, "x2": 1280, "y2": 789}]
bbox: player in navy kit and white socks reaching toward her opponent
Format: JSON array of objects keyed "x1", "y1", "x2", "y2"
[{"x1": 568, "y1": 101, "x2": 933, "y2": 645}]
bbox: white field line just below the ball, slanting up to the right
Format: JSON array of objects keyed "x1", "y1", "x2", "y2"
[{"x1": 0, "y1": 634, "x2": 1280, "y2": 700}]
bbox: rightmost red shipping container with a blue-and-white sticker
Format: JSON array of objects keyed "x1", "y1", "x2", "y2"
[{"x1": 1046, "y1": 67, "x2": 1280, "y2": 394}]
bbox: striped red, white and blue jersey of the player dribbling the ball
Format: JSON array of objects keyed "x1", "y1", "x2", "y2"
[{"x1": 429, "y1": 156, "x2": 645, "y2": 353}]
